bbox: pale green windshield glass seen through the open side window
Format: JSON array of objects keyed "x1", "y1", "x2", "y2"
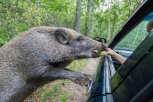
[{"x1": 115, "y1": 20, "x2": 148, "y2": 50}]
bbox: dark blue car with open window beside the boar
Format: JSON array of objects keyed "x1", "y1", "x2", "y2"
[{"x1": 88, "y1": 0, "x2": 153, "y2": 102}]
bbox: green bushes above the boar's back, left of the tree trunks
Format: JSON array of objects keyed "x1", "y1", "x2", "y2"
[{"x1": 0, "y1": 0, "x2": 75, "y2": 45}]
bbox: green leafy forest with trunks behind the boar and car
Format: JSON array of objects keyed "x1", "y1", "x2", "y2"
[{"x1": 0, "y1": 0, "x2": 143, "y2": 46}]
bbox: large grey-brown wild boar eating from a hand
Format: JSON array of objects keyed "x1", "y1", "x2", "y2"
[{"x1": 0, "y1": 26, "x2": 105, "y2": 102}]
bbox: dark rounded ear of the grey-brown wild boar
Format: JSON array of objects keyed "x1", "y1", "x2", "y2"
[{"x1": 55, "y1": 29, "x2": 70, "y2": 44}]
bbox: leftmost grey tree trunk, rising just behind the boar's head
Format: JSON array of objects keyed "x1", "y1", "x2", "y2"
[{"x1": 74, "y1": 0, "x2": 82, "y2": 32}]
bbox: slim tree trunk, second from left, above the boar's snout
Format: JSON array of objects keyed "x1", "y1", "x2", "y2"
[{"x1": 85, "y1": 0, "x2": 91, "y2": 36}]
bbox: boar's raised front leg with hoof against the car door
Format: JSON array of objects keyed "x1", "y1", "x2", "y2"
[{"x1": 42, "y1": 68, "x2": 91, "y2": 86}]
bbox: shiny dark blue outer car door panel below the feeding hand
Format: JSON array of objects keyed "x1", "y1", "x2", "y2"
[{"x1": 88, "y1": 55, "x2": 116, "y2": 102}]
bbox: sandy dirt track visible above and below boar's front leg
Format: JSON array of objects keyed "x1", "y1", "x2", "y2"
[{"x1": 63, "y1": 58, "x2": 99, "y2": 102}]
